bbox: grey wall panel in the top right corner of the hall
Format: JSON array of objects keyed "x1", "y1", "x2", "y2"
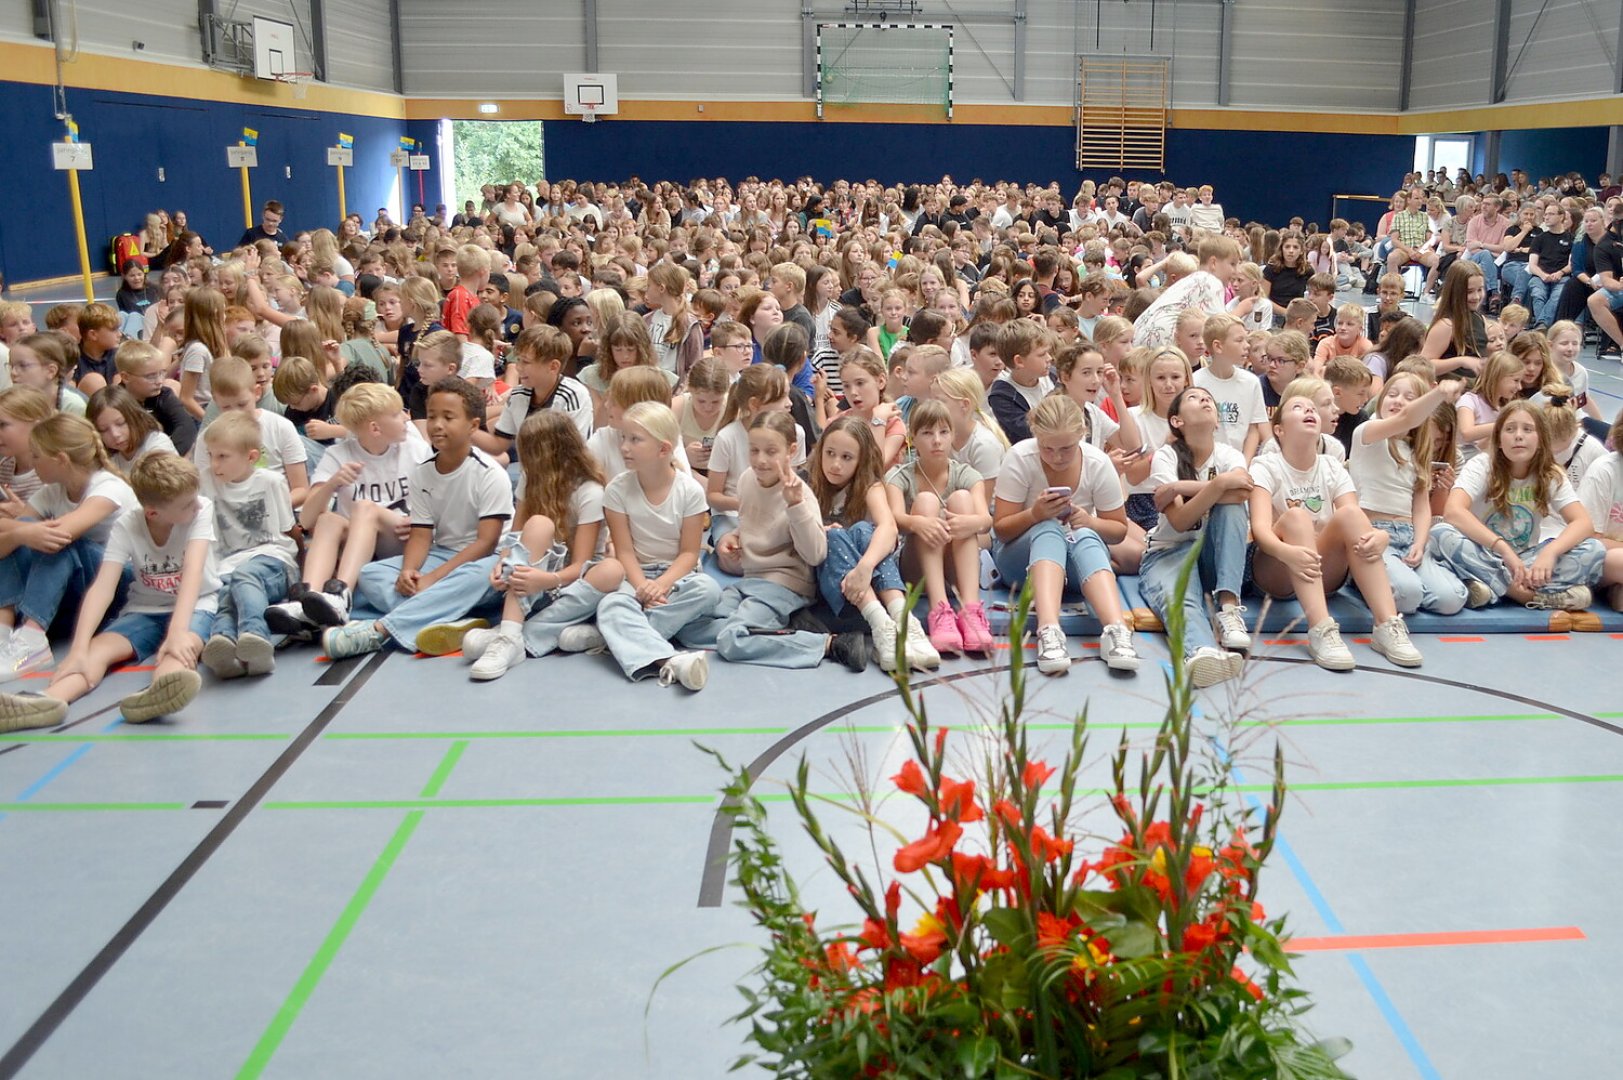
[{"x1": 1506, "y1": 0, "x2": 1623, "y2": 102}]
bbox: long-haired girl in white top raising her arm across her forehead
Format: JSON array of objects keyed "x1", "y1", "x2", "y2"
[{"x1": 1347, "y1": 372, "x2": 1466, "y2": 616}]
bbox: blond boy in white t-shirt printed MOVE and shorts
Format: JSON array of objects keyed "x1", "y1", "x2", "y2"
[{"x1": 265, "y1": 383, "x2": 433, "y2": 633}]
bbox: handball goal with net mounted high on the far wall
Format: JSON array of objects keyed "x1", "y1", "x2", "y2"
[{"x1": 816, "y1": 23, "x2": 953, "y2": 119}]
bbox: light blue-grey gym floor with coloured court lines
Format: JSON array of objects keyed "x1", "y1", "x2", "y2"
[{"x1": 0, "y1": 613, "x2": 1623, "y2": 1080}]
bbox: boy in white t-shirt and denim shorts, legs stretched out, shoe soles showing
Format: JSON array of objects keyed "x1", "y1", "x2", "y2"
[{"x1": 0, "y1": 453, "x2": 219, "y2": 731}]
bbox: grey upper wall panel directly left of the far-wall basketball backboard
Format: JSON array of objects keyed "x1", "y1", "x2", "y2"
[{"x1": 401, "y1": 0, "x2": 584, "y2": 97}]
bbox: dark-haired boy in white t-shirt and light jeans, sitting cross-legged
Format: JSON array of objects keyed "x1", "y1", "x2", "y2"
[{"x1": 321, "y1": 378, "x2": 513, "y2": 659}]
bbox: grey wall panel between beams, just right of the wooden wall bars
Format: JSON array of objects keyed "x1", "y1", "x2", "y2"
[{"x1": 1229, "y1": 0, "x2": 1404, "y2": 110}]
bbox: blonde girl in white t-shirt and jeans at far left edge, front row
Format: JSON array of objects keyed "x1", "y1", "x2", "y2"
[{"x1": 0, "y1": 413, "x2": 136, "y2": 680}]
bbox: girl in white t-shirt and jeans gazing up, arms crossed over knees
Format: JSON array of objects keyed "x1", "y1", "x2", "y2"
[{"x1": 1138, "y1": 387, "x2": 1251, "y2": 687}]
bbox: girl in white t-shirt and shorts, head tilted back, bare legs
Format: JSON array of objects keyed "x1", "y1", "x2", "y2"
[{"x1": 1251, "y1": 383, "x2": 1422, "y2": 671}]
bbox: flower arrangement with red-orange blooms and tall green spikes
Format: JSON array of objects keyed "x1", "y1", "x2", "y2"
[{"x1": 724, "y1": 568, "x2": 1347, "y2": 1080}]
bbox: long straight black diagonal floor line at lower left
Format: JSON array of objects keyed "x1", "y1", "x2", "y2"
[{"x1": 0, "y1": 650, "x2": 390, "y2": 1080}]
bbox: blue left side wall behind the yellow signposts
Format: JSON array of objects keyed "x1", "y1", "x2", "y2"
[{"x1": 0, "y1": 83, "x2": 406, "y2": 283}]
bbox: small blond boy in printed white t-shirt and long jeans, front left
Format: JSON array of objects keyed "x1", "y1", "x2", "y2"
[{"x1": 203, "y1": 413, "x2": 299, "y2": 679}]
